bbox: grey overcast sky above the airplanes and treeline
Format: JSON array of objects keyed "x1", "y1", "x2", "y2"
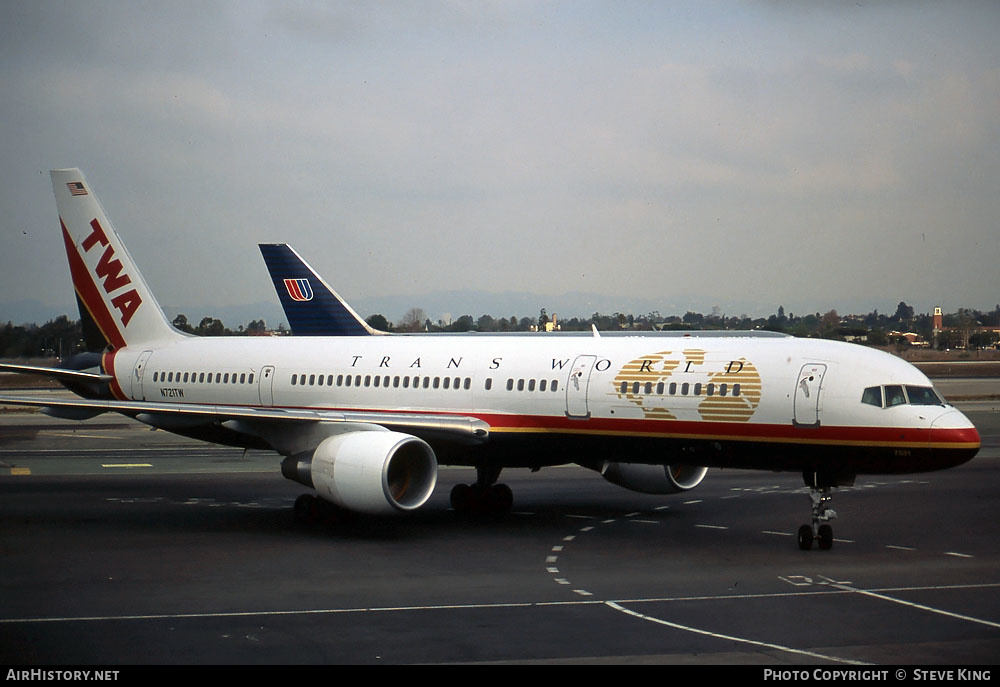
[{"x1": 0, "y1": 0, "x2": 1000, "y2": 320}]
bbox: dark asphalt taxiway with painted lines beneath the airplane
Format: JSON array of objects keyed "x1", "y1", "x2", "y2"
[{"x1": 0, "y1": 401, "x2": 1000, "y2": 666}]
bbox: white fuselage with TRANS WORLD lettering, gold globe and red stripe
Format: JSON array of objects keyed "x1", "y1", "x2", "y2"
[{"x1": 105, "y1": 334, "x2": 978, "y2": 471}]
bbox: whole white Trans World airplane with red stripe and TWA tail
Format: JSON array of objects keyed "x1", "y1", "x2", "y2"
[{"x1": 0, "y1": 169, "x2": 981, "y2": 549}]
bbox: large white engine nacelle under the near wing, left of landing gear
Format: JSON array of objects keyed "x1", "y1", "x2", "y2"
[{"x1": 281, "y1": 431, "x2": 437, "y2": 514}]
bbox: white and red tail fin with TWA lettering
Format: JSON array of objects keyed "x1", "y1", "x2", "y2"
[{"x1": 51, "y1": 169, "x2": 184, "y2": 349}]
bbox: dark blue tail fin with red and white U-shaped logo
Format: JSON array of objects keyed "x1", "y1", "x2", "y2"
[{"x1": 259, "y1": 243, "x2": 386, "y2": 336}]
